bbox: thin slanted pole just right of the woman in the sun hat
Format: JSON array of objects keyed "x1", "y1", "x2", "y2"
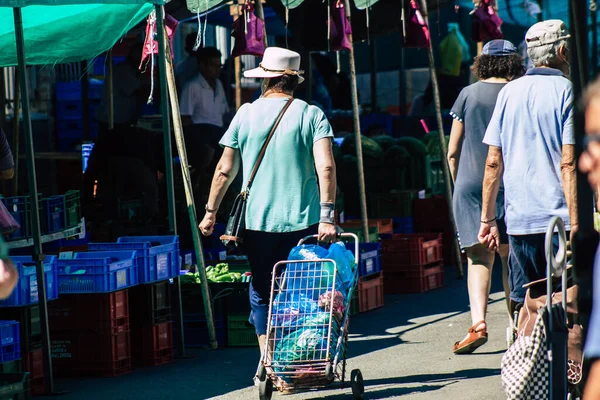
[{"x1": 344, "y1": 0, "x2": 369, "y2": 243}]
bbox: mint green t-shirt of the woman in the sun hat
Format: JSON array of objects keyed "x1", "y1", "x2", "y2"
[{"x1": 220, "y1": 98, "x2": 333, "y2": 232}]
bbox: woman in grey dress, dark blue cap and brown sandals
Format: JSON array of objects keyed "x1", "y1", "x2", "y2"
[{"x1": 448, "y1": 40, "x2": 525, "y2": 354}]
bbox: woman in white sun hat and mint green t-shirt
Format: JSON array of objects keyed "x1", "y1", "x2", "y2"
[{"x1": 200, "y1": 47, "x2": 336, "y2": 353}]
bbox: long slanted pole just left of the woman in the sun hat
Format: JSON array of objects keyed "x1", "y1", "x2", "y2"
[{"x1": 159, "y1": 21, "x2": 218, "y2": 349}]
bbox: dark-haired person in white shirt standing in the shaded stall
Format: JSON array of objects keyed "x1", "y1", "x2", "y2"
[{"x1": 179, "y1": 47, "x2": 230, "y2": 174}]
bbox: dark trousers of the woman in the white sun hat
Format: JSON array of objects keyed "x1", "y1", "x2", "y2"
[{"x1": 244, "y1": 225, "x2": 318, "y2": 335}]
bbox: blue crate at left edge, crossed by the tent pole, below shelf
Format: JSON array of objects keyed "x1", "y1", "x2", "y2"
[{"x1": 0, "y1": 256, "x2": 58, "y2": 307}]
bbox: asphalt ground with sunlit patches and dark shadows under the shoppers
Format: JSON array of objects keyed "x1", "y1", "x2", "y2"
[{"x1": 41, "y1": 260, "x2": 508, "y2": 400}]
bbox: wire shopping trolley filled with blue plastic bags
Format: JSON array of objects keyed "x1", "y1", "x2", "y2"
[{"x1": 257, "y1": 233, "x2": 364, "y2": 400}]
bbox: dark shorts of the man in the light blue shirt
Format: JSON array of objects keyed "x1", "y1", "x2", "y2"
[{"x1": 508, "y1": 233, "x2": 569, "y2": 303}]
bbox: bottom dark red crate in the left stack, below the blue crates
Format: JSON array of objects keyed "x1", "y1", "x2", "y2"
[{"x1": 51, "y1": 327, "x2": 131, "y2": 376}]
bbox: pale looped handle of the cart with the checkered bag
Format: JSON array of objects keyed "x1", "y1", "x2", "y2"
[{"x1": 545, "y1": 217, "x2": 567, "y2": 316}]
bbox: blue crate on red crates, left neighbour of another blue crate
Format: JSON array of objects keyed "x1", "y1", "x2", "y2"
[{"x1": 58, "y1": 251, "x2": 138, "y2": 294}]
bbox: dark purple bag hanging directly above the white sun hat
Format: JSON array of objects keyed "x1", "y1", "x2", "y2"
[{"x1": 231, "y1": 0, "x2": 265, "y2": 57}]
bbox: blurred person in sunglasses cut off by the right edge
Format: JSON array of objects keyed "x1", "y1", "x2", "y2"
[{"x1": 579, "y1": 80, "x2": 600, "y2": 400}]
